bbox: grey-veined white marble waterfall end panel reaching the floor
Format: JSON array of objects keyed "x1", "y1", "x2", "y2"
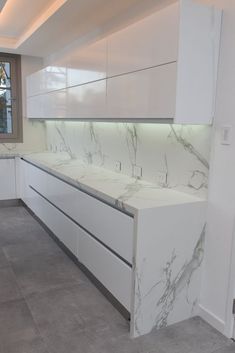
[{"x1": 131, "y1": 201, "x2": 206, "y2": 337}]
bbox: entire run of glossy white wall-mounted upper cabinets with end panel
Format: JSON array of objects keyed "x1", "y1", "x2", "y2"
[{"x1": 27, "y1": 0, "x2": 221, "y2": 124}]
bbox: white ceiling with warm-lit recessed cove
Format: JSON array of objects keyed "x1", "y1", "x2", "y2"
[{"x1": 0, "y1": 0, "x2": 176, "y2": 57}]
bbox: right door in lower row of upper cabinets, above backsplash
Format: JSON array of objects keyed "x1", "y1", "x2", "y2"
[{"x1": 107, "y1": 63, "x2": 177, "y2": 119}]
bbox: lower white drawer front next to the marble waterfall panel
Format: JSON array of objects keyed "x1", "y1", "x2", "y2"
[{"x1": 78, "y1": 230, "x2": 132, "y2": 311}]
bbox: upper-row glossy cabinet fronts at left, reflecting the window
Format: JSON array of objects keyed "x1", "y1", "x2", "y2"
[{"x1": 27, "y1": 39, "x2": 107, "y2": 97}]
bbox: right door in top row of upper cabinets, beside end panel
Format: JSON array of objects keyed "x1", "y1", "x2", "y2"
[{"x1": 108, "y1": 3, "x2": 179, "y2": 77}]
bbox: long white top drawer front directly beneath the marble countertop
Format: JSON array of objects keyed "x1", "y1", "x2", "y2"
[{"x1": 26, "y1": 161, "x2": 133, "y2": 263}]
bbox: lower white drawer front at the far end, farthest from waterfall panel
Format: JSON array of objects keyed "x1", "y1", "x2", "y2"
[{"x1": 27, "y1": 187, "x2": 79, "y2": 257}]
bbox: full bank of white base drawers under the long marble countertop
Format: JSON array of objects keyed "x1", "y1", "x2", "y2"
[{"x1": 20, "y1": 160, "x2": 134, "y2": 312}]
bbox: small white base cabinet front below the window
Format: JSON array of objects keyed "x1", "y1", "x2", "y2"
[{"x1": 0, "y1": 158, "x2": 17, "y2": 200}]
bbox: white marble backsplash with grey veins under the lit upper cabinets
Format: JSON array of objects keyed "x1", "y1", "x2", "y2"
[{"x1": 46, "y1": 121, "x2": 211, "y2": 196}]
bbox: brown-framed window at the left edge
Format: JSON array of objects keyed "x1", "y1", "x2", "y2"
[{"x1": 0, "y1": 53, "x2": 22, "y2": 143}]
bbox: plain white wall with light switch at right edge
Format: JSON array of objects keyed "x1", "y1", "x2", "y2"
[{"x1": 201, "y1": 0, "x2": 235, "y2": 337}]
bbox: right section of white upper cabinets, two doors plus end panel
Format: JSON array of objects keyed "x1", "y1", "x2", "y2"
[{"x1": 107, "y1": 0, "x2": 221, "y2": 124}]
